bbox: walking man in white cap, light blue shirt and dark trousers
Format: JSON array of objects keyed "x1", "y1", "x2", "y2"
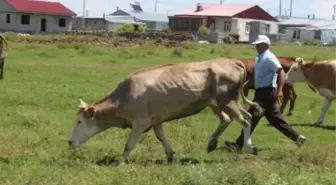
[{"x1": 225, "y1": 35, "x2": 307, "y2": 150}]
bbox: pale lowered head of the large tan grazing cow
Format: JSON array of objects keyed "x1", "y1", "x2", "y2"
[{"x1": 69, "y1": 99, "x2": 106, "y2": 147}]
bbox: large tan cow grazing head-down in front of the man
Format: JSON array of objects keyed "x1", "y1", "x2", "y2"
[{"x1": 69, "y1": 58, "x2": 262, "y2": 164}]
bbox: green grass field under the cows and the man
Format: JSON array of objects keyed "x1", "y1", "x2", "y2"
[{"x1": 0, "y1": 36, "x2": 336, "y2": 185}]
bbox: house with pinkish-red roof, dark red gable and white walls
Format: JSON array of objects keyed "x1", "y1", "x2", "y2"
[{"x1": 169, "y1": 3, "x2": 278, "y2": 42}]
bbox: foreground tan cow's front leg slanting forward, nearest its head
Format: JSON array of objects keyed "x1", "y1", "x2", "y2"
[{"x1": 115, "y1": 121, "x2": 150, "y2": 166}]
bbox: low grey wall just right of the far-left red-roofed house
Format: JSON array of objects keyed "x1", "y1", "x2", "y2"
[{"x1": 72, "y1": 17, "x2": 108, "y2": 30}]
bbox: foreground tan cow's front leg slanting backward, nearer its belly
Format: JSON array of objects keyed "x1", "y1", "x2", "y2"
[{"x1": 153, "y1": 123, "x2": 175, "y2": 163}]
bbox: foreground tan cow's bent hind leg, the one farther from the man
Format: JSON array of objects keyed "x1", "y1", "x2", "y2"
[{"x1": 208, "y1": 106, "x2": 231, "y2": 152}]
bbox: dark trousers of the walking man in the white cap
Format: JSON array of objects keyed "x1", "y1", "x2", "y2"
[{"x1": 236, "y1": 87, "x2": 299, "y2": 147}]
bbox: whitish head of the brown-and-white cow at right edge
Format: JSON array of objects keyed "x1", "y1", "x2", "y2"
[{"x1": 286, "y1": 58, "x2": 306, "y2": 84}]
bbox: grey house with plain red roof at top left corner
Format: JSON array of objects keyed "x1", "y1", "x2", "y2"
[{"x1": 0, "y1": 0, "x2": 76, "y2": 33}]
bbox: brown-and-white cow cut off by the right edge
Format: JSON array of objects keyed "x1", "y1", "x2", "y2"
[{"x1": 286, "y1": 58, "x2": 336, "y2": 126}]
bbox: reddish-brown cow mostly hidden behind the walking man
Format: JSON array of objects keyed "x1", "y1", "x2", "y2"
[{"x1": 239, "y1": 56, "x2": 297, "y2": 116}]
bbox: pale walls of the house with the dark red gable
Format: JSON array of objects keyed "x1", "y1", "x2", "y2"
[{"x1": 212, "y1": 17, "x2": 278, "y2": 42}]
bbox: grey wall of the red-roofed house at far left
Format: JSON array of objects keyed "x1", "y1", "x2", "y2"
[{"x1": 0, "y1": 12, "x2": 72, "y2": 33}]
